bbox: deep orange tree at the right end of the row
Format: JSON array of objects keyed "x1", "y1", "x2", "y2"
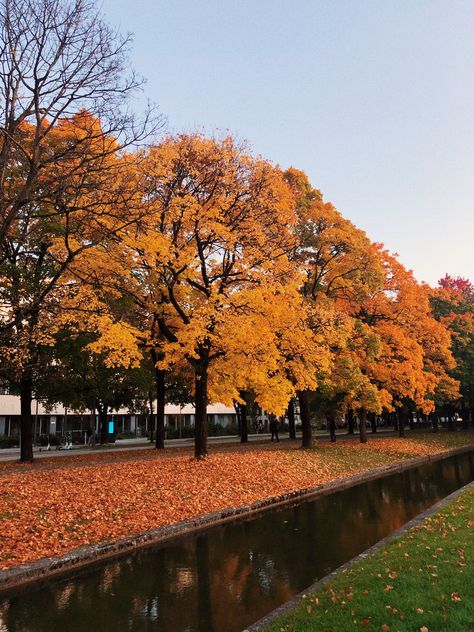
[{"x1": 353, "y1": 246, "x2": 457, "y2": 436}]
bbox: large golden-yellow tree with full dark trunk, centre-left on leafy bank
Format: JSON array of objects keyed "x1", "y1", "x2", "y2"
[{"x1": 90, "y1": 134, "x2": 318, "y2": 457}]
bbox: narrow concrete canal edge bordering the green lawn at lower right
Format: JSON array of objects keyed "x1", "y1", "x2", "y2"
[{"x1": 243, "y1": 481, "x2": 474, "y2": 632}]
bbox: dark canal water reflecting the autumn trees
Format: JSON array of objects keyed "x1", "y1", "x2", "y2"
[{"x1": 0, "y1": 452, "x2": 474, "y2": 632}]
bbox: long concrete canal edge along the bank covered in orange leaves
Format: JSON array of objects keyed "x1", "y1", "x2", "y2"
[{"x1": 0, "y1": 445, "x2": 474, "y2": 592}]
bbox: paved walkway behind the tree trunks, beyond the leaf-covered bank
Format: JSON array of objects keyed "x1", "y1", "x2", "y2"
[{"x1": 0, "y1": 428, "x2": 408, "y2": 463}]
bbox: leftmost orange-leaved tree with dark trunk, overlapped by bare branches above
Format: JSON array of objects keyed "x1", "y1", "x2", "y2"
[{"x1": 0, "y1": 112, "x2": 143, "y2": 460}]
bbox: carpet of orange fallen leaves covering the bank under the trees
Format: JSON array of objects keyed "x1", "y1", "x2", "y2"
[{"x1": 0, "y1": 433, "x2": 472, "y2": 569}]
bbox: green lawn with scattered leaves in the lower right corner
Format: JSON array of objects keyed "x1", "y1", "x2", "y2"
[{"x1": 266, "y1": 487, "x2": 474, "y2": 632}]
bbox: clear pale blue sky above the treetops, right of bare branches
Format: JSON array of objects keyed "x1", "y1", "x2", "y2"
[{"x1": 103, "y1": 0, "x2": 474, "y2": 284}]
